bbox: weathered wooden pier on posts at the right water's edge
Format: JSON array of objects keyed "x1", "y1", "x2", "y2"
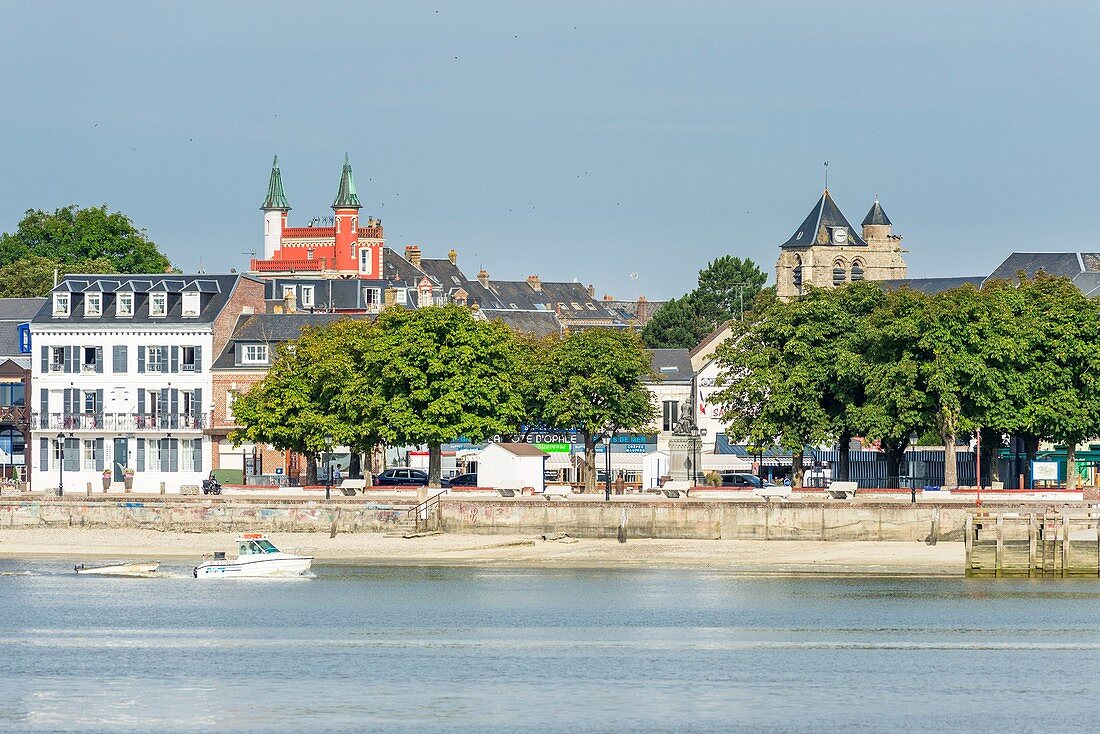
[{"x1": 966, "y1": 510, "x2": 1100, "y2": 578}]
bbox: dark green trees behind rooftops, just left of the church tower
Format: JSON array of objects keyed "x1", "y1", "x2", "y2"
[{"x1": 641, "y1": 255, "x2": 768, "y2": 349}]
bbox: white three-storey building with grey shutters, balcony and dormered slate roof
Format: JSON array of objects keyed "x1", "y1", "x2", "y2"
[{"x1": 28, "y1": 275, "x2": 263, "y2": 493}]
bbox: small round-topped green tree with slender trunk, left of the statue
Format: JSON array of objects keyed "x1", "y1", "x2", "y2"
[{"x1": 541, "y1": 329, "x2": 656, "y2": 491}]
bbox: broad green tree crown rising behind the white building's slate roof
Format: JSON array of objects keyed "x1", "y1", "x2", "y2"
[{"x1": 0, "y1": 205, "x2": 172, "y2": 295}]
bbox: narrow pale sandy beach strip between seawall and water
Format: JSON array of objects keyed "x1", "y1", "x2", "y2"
[{"x1": 0, "y1": 528, "x2": 965, "y2": 576}]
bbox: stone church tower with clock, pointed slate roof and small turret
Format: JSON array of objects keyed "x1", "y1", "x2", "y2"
[{"x1": 776, "y1": 188, "x2": 908, "y2": 300}]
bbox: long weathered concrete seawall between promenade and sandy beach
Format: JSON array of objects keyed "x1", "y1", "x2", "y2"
[{"x1": 0, "y1": 499, "x2": 998, "y2": 541}]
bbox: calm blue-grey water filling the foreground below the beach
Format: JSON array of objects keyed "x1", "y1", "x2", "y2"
[{"x1": 0, "y1": 561, "x2": 1100, "y2": 734}]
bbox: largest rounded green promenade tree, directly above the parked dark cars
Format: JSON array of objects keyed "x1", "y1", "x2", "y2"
[{"x1": 341, "y1": 306, "x2": 523, "y2": 486}]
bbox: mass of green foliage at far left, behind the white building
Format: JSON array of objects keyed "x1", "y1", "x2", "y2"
[{"x1": 0, "y1": 205, "x2": 172, "y2": 297}]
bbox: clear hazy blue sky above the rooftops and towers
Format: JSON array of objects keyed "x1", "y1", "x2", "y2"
[{"x1": 0, "y1": 0, "x2": 1100, "y2": 298}]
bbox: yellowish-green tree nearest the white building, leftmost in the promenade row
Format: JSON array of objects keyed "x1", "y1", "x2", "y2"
[{"x1": 229, "y1": 329, "x2": 360, "y2": 484}]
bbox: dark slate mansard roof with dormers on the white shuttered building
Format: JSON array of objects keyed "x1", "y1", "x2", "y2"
[{"x1": 31, "y1": 273, "x2": 261, "y2": 326}]
